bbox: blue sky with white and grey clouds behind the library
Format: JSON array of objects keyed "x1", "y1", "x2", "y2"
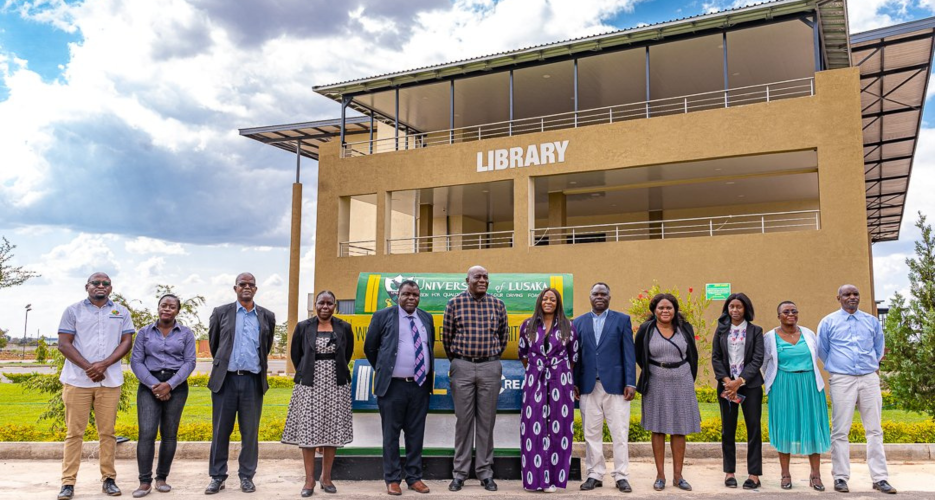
[{"x1": 0, "y1": 0, "x2": 935, "y2": 335}]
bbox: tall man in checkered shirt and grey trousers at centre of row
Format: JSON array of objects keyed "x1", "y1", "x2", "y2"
[{"x1": 442, "y1": 266, "x2": 509, "y2": 491}]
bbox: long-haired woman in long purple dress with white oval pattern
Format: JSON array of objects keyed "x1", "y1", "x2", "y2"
[{"x1": 519, "y1": 288, "x2": 578, "y2": 493}]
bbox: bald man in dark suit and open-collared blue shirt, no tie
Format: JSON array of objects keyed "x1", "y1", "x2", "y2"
[{"x1": 205, "y1": 273, "x2": 276, "y2": 495}]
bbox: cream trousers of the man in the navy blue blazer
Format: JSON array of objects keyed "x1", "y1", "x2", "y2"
[{"x1": 579, "y1": 380, "x2": 630, "y2": 482}]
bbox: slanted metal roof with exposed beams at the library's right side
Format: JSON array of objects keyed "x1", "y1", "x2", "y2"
[{"x1": 851, "y1": 17, "x2": 935, "y2": 242}]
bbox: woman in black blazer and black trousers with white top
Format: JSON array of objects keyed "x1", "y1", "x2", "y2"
[{"x1": 711, "y1": 293, "x2": 764, "y2": 490}]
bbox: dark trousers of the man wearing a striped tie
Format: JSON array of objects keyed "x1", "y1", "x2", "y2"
[{"x1": 377, "y1": 378, "x2": 429, "y2": 484}]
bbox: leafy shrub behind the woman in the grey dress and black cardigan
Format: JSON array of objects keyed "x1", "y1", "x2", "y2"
[{"x1": 628, "y1": 281, "x2": 711, "y2": 375}]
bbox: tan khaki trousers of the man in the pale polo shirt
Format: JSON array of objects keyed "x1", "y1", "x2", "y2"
[{"x1": 62, "y1": 384, "x2": 120, "y2": 485}]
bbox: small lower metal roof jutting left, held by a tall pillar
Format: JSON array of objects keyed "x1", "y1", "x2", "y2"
[{"x1": 240, "y1": 116, "x2": 370, "y2": 160}]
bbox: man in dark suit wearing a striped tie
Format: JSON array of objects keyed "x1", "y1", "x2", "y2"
[{"x1": 364, "y1": 280, "x2": 435, "y2": 495}]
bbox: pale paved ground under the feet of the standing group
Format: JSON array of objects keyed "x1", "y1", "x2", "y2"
[{"x1": 0, "y1": 459, "x2": 935, "y2": 500}]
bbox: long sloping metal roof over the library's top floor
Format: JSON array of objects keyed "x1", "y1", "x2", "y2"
[{"x1": 313, "y1": 0, "x2": 850, "y2": 101}]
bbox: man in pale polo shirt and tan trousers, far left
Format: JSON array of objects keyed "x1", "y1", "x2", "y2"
[{"x1": 58, "y1": 273, "x2": 136, "y2": 500}]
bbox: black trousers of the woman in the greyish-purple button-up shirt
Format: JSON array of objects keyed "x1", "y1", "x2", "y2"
[{"x1": 136, "y1": 372, "x2": 188, "y2": 483}]
